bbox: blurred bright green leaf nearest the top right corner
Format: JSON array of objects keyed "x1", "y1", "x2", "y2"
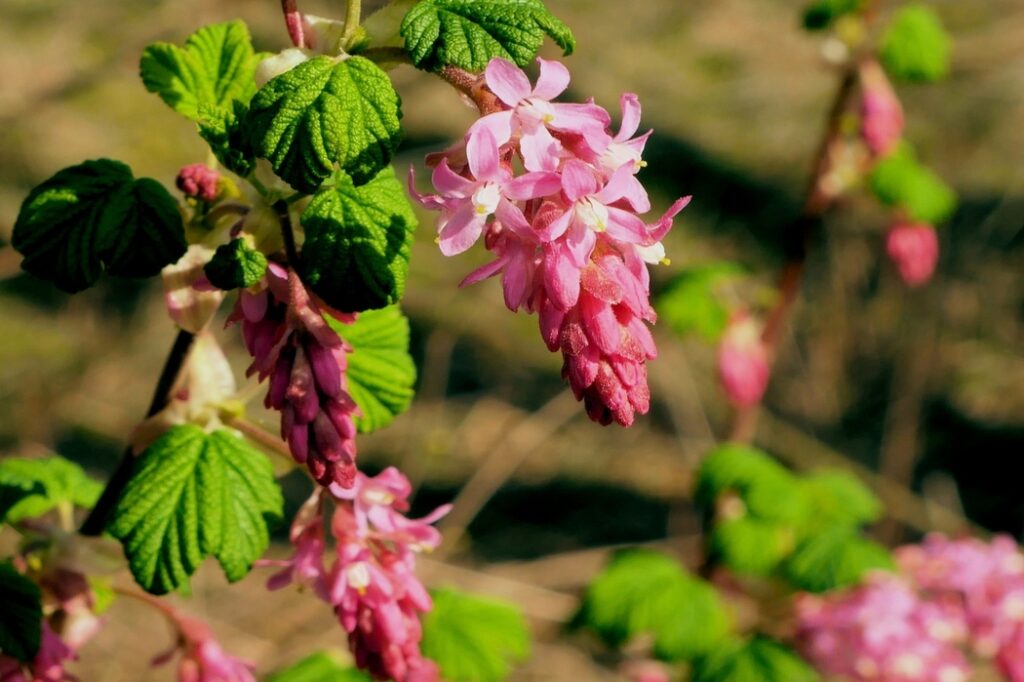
[{"x1": 881, "y1": 4, "x2": 952, "y2": 82}]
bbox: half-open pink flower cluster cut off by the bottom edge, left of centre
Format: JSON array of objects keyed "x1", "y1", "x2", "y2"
[{"x1": 264, "y1": 467, "x2": 450, "y2": 682}]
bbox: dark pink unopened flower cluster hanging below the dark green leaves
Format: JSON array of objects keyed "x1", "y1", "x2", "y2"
[{"x1": 230, "y1": 263, "x2": 356, "y2": 487}]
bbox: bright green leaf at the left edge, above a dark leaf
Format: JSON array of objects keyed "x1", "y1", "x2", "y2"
[{"x1": 0, "y1": 456, "x2": 103, "y2": 523}]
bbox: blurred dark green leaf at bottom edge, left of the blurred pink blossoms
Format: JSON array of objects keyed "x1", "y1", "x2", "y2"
[{"x1": 691, "y1": 635, "x2": 820, "y2": 682}]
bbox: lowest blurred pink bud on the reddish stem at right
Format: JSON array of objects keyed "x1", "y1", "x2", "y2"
[{"x1": 718, "y1": 313, "x2": 771, "y2": 408}]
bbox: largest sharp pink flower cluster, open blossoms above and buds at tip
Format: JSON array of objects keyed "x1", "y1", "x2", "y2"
[{"x1": 410, "y1": 58, "x2": 688, "y2": 426}]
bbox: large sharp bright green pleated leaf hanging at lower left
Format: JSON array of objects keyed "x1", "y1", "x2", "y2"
[{"x1": 109, "y1": 424, "x2": 284, "y2": 594}]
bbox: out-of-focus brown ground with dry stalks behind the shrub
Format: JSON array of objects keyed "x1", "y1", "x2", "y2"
[{"x1": 0, "y1": 0, "x2": 1024, "y2": 680}]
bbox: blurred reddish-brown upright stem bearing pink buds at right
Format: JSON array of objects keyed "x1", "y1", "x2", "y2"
[{"x1": 729, "y1": 63, "x2": 857, "y2": 442}]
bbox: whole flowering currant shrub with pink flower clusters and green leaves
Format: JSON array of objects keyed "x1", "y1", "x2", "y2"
[{"x1": 0, "y1": 0, "x2": 991, "y2": 682}]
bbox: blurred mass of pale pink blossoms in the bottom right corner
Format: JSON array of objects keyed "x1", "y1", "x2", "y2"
[{"x1": 797, "y1": 536, "x2": 1024, "y2": 682}]
